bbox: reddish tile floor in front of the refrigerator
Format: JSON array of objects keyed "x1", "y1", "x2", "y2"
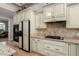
[{"x1": 1, "y1": 39, "x2": 41, "y2": 56}]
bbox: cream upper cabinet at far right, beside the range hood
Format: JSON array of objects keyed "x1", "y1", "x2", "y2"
[{"x1": 66, "y1": 4, "x2": 79, "y2": 28}]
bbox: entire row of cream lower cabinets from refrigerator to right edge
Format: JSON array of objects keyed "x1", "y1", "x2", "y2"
[{"x1": 31, "y1": 38, "x2": 79, "y2": 56}]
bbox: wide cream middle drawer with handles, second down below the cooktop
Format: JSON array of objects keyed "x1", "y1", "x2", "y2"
[{"x1": 44, "y1": 44, "x2": 68, "y2": 54}]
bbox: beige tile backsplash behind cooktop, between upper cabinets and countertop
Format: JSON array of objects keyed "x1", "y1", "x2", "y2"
[{"x1": 37, "y1": 22, "x2": 79, "y2": 38}]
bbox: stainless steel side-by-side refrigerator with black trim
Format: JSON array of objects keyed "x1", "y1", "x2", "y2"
[{"x1": 19, "y1": 20, "x2": 30, "y2": 52}]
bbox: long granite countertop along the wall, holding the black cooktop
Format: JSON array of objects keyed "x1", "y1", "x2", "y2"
[{"x1": 31, "y1": 36, "x2": 79, "y2": 44}]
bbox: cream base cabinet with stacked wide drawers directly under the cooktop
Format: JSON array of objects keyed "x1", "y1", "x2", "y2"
[{"x1": 44, "y1": 40, "x2": 68, "y2": 56}]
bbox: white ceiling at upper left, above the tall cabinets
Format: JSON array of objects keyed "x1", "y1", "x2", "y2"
[{"x1": 0, "y1": 3, "x2": 51, "y2": 18}]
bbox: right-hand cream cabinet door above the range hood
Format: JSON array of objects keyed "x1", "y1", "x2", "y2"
[{"x1": 54, "y1": 3, "x2": 66, "y2": 17}]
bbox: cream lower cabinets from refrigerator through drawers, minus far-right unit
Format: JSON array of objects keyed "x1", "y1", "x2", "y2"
[{"x1": 32, "y1": 39, "x2": 68, "y2": 56}]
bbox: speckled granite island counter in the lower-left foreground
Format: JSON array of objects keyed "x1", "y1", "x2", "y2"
[{"x1": 0, "y1": 43, "x2": 15, "y2": 56}]
